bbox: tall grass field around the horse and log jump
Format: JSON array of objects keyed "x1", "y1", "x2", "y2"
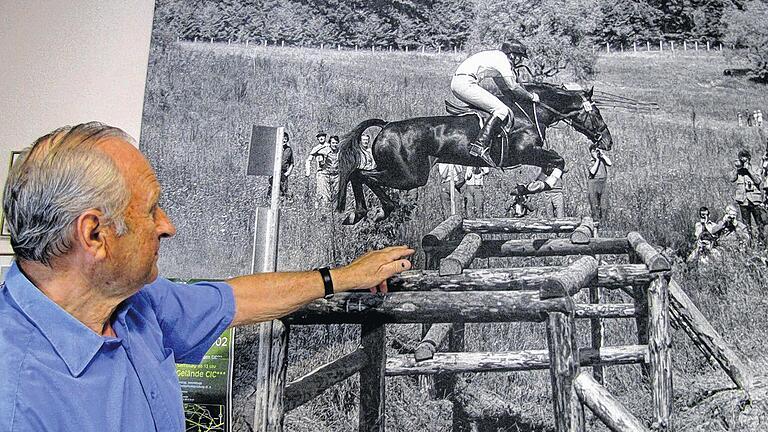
[{"x1": 141, "y1": 44, "x2": 768, "y2": 432}]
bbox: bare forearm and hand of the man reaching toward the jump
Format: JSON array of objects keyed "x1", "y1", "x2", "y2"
[{"x1": 227, "y1": 246, "x2": 414, "y2": 326}]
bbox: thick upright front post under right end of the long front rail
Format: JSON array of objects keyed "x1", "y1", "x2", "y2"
[{"x1": 547, "y1": 308, "x2": 584, "y2": 432}]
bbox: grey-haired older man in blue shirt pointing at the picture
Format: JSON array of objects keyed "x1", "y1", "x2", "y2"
[{"x1": 0, "y1": 123, "x2": 413, "y2": 432}]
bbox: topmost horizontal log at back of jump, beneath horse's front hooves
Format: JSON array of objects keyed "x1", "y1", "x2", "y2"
[{"x1": 462, "y1": 218, "x2": 582, "y2": 234}]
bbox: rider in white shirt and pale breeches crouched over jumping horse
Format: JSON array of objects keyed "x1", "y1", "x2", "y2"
[{"x1": 451, "y1": 38, "x2": 539, "y2": 167}]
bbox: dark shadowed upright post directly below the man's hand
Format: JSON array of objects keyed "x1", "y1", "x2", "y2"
[{"x1": 357, "y1": 322, "x2": 387, "y2": 432}]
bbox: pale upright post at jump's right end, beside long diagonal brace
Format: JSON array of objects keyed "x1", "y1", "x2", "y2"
[{"x1": 648, "y1": 275, "x2": 672, "y2": 431}]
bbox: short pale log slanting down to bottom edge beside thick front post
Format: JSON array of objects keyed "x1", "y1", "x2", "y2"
[{"x1": 574, "y1": 372, "x2": 648, "y2": 432}]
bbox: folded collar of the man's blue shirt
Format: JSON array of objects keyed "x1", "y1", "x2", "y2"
[{"x1": 5, "y1": 262, "x2": 106, "y2": 377}]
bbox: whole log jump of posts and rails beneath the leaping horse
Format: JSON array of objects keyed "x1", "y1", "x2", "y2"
[{"x1": 254, "y1": 216, "x2": 750, "y2": 432}]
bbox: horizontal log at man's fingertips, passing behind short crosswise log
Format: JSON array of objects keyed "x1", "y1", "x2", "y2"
[{"x1": 387, "y1": 264, "x2": 654, "y2": 292}]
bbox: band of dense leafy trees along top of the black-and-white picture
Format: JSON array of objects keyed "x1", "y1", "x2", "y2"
[{"x1": 154, "y1": 0, "x2": 768, "y2": 81}]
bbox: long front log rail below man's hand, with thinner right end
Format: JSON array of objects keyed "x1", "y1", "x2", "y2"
[{"x1": 283, "y1": 291, "x2": 635, "y2": 324}]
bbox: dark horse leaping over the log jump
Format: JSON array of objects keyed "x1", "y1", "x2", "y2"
[{"x1": 336, "y1": 84, "x2": 613, "y2": 224}]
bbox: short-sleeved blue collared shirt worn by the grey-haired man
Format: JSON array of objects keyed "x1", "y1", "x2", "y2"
[{"x1": 0, "y1": 264, "x2": 235, "y2": 432}]
